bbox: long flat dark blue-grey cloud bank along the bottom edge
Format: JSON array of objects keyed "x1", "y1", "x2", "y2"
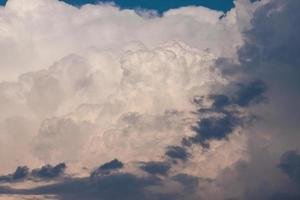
[{"x1": 0, "y1": 160, "x2": 199, "y2": 200}]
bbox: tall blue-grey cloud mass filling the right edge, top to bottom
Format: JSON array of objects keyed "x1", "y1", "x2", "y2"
[{"x1": 206, "y1": 0, "x2": 300, "y2": 200}]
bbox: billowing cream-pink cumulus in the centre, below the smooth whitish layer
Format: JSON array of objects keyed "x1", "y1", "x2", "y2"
[{"x1": 1, "y1": 38, "x2": 230, "y2": 172}]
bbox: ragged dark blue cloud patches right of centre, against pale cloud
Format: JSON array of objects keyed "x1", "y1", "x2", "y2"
[{"x1": 182, "y1": 80, "x2": 267, "y2": 148}]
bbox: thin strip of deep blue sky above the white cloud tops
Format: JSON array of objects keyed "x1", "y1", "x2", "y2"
[{"x1": 0, "y1": 0, "x2": 233, "y2": 13}]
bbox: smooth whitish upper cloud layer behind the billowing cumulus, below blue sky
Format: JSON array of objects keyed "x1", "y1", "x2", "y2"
[{"x1": 0, "y1": 0, "x2": 246, "y2": 80}]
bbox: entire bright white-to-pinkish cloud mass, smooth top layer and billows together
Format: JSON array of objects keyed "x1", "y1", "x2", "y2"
[{"x1": 0, "y1": 0, "x2": 262, "y2": 189}]
